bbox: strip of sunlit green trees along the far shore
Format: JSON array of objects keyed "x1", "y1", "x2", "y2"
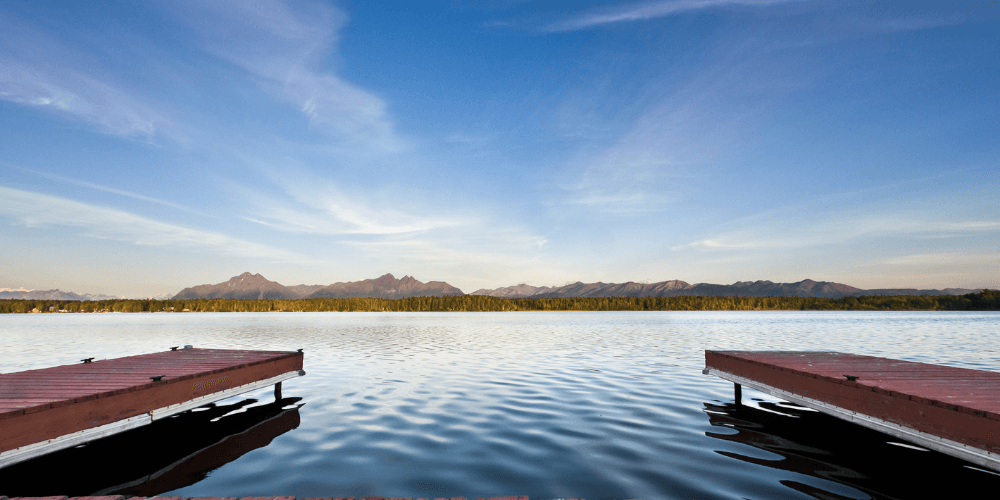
[{"x1": 0, "y1": 290, "x2": 1000, "y2": 313}]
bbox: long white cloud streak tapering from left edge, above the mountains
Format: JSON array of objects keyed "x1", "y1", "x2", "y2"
[{"x1": 0, "y1": 186, "x2": 316, "y2": 264}]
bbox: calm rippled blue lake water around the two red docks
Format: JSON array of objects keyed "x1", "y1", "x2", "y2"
[{"x1": 0, "y1": 312, "x2": 1000, "y2": 500}]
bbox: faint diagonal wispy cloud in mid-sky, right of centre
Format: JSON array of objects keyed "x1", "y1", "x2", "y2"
[{"x1": 559, "y1": 40, "x2": 772, "y2": 214}]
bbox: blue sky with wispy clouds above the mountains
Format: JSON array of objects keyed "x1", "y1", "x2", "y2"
[{"x1": 0, "y1": 0, "x2": 1000, "y2": 297}]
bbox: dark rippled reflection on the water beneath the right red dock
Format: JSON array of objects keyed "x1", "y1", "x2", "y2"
[{"x1": 704, "y1": 398, "x2": 1000, "y2": 499}]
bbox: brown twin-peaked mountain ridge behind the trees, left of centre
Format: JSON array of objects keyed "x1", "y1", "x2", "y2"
[{"x1": 173, "y1": 272, "x2": 464, "y2": 300}]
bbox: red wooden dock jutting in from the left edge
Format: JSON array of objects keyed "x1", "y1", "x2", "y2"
[{"x1": 0, "y1": 346, "x2": 305, "y2": 467}]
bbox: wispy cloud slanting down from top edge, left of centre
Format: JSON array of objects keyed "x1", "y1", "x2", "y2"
[{"x1": 175, "y1": 0, "x2": 405, "y2": 151}]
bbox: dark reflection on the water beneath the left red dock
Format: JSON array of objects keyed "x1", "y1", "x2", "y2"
[{"x1": 0, "y1": 398, "x2": 302, "y2": 498}]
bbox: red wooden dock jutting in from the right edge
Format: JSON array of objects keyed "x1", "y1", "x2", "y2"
[{"x1": 702, "y1": 351, "x2": 1000, "y2": 472}]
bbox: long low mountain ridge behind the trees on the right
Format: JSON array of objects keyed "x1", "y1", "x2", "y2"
[{"x1": 472, "y1": 279, "x2": 980, "y2": 299}]
